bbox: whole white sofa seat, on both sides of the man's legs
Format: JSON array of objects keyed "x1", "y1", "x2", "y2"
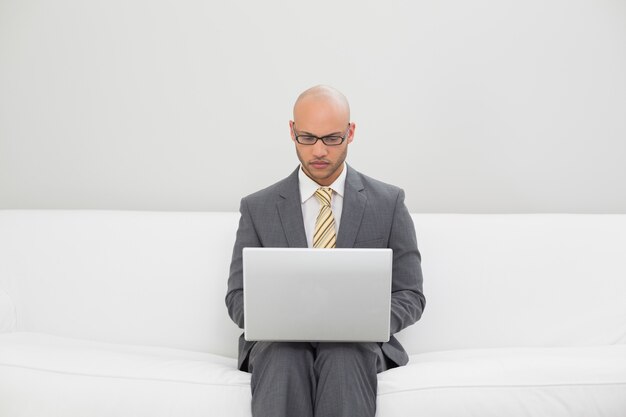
[{"x1": 0, "y1": 332, "x2": 626, "y2": 417}]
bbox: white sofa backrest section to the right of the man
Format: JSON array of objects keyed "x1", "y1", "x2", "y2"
[{"x1": 398, "y1": 214, "x2": 626, "y2": 352}]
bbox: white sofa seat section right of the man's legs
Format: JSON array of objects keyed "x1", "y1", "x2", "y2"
[{"x1": 378, "y1": 345, "x2": 626, "y2": 417}]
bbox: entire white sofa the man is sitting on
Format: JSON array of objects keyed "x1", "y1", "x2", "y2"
[{"x1": 0, "y1": 210, "x2": 626, "y2": 417}]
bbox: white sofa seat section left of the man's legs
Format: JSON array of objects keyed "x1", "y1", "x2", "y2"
[{"x1": 0, "y1": 332, "x2": 250, "y2": 417}]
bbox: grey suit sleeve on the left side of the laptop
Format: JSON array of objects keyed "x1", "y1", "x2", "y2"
[{"x1": 226, "y1": 199, "x2": 261, "y2": 329}]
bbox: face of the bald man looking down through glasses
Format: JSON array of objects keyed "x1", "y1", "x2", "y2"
[{"x1": 289, "y1": 98, "x2": 355, "y2": 186}]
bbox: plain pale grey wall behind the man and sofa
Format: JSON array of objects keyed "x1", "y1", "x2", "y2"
[{"x1": 0, "y1": 0, "x2": 626, "y2": 213}]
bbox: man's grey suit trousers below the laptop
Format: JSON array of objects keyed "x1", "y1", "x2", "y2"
[{"x1": 248, "y1": 342, "x2": 387, "y2": 417}]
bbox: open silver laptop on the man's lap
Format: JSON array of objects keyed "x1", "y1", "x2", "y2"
[{"x1": 243, "y1": 248, "x2": 393, "y2": 342}]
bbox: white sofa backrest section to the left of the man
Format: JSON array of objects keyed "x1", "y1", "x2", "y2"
[{"x1": 0, "y1": 210, "x2": 241, "y2": 357}]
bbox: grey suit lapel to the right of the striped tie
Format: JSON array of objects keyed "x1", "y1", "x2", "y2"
[{"x1": 337, "y1": 165, "x2": 367, "y2": 248}]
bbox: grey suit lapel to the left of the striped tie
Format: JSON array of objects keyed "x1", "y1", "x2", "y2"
[{"x1": 276, "y1": 167, "x2": 307, "y2": 248}]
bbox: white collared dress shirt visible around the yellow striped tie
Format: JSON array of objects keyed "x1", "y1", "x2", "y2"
[{"x1": 298, "y1": 162, "x2": 347, "y2": 248}]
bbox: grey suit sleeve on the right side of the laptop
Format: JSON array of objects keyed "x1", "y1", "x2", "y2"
[{"x1": 389, "y1": 190, "x2": 426, "y2": 335}]
